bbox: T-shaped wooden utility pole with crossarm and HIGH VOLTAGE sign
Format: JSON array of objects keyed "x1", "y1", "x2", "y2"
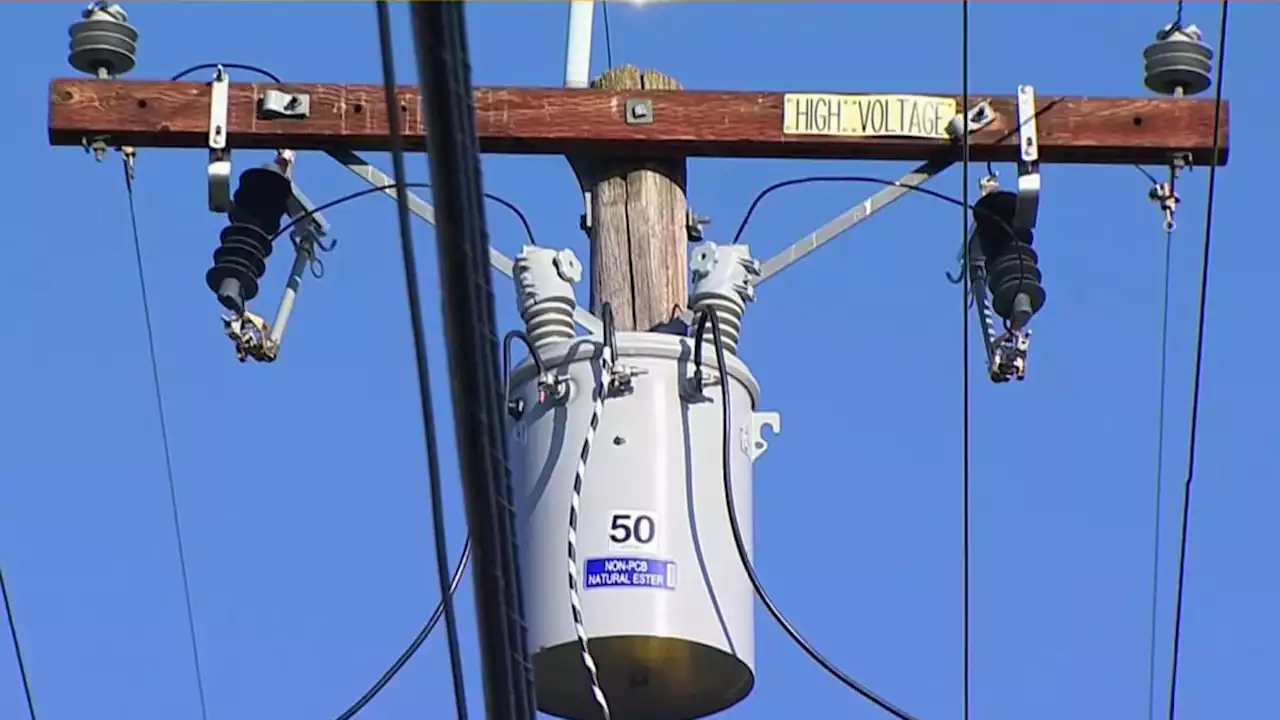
[{"x1": 49, "y1": 77, "x2": 1229, "y2": 331}]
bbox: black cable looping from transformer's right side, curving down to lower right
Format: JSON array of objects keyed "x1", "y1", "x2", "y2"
[{"x1": 694, "y1": 311, "x2": 916, "y2": 720}]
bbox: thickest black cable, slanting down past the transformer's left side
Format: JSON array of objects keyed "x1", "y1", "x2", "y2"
[{"x1": 410, "y1": 3, "x2": 538, "y2": 720}]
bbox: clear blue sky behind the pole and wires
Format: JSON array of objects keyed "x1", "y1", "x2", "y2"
[{"x1": 0, "y1": 3, "x2": 1280, "y2": 720}]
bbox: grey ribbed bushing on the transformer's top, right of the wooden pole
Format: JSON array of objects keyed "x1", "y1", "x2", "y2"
[{"x1": 689, "y1": 242, "x2": 760, "y2": 354}]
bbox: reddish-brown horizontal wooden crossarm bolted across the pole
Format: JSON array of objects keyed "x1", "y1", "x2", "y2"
[{"x1": 49, "y1": 78, "x2": 1229, "y2": 165}]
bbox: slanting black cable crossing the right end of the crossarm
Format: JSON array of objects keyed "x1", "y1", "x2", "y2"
[{"x1": 1169, "y1": 0, "x2": 1230, "y2": 720}]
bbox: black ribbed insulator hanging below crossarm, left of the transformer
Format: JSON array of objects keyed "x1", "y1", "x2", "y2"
[{"x1": 205, "y1": 168, "x2": 293, "y2": 314}]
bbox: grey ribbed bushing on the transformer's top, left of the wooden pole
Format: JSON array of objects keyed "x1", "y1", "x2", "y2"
[{"x1": 512, "y1": 245, "x2": 582, "y2": 350}]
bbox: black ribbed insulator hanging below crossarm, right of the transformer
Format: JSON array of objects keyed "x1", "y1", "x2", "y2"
[{"x1": 973, "y1": 191, "x2": 1044, "y2": 328}]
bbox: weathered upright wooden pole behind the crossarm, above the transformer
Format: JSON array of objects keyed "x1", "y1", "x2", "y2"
[{"x1": 570, "y1": 65, "x2": 689, "y2": 331}]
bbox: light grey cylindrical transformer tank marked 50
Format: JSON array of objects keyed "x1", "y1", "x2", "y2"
[{"x1": 508, "y1": 333, "x2": 778, "y2": 720}]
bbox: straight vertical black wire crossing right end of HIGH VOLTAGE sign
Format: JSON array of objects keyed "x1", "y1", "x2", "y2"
[{"x1": 960, "y1": 0, "x2": 973, "y2": 720}]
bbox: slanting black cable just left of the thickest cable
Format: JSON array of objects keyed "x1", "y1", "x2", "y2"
[{"x1": 375, "y1": 0, "x2": 467, "y2": 720}]
